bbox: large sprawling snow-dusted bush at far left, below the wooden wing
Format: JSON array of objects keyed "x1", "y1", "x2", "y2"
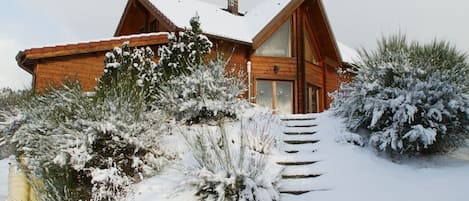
[{"x1": 0, "y1": 81, "x2": 175, "y2": 200}]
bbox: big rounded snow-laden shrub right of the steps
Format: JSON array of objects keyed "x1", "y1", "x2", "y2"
[{"x1": 333, "y1": 35, "x2": 469, "y2": 154}]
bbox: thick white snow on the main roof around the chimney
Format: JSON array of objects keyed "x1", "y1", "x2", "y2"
[{"x1": 149, "y1": 0, "x2": 291, "y2": 43}]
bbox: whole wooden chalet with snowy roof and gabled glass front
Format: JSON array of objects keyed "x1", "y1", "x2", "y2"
[{"x1": 17, "y1": 0, "x2": 350, "y2": 113}]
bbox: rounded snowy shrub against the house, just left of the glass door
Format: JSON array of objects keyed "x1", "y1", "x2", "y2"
[{"x1": 155, "y1": 56, "x2": 247, "y2": 122}]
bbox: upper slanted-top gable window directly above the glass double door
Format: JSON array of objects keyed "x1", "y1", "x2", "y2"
[{"x1": 256, "y1": 20, "x2": 291, "y2": 57}]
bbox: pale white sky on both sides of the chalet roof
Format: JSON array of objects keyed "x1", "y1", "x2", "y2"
[{"x1": 0, "y1": 0, "x2": 469, "y2": 89}]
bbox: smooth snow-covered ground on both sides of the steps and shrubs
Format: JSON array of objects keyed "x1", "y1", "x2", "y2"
[{"x1": 131, "y1": 112, "x2": 469, "y2": 201}]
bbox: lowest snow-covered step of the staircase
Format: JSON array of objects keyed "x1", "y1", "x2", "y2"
[{"x1": 279, "y1": 176, "x2": 332, "y2": 194}]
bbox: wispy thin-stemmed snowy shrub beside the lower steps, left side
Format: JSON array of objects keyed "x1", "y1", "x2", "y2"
[{"x1": 184, "y1": 117, "x2": 282, "y2": 201}]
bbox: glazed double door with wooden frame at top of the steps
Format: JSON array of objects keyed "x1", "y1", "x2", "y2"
[{"x1": 256, "y1": 80, "x2": 293, "y2": 114}]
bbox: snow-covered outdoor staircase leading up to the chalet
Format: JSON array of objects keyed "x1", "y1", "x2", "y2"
[{"x1": 277, "y1": 114, "x2": 329, "y2": 197}]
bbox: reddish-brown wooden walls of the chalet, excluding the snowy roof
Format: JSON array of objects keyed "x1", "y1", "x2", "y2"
[{"x1": 17, "y1": 0, "x2": 342, "y2": 113}]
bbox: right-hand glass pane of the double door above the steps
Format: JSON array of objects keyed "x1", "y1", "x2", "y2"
[{"x1": 276, "y1": 81, "x2": 293, "y2": 114}]
